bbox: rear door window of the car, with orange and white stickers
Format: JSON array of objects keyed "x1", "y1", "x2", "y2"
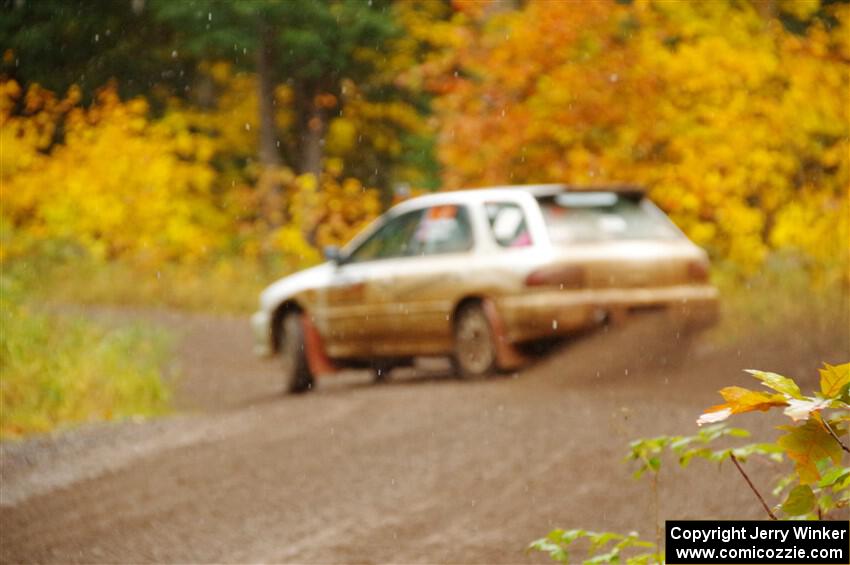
[{"x1": 412, "y1": 204, "x2": 473, "y2": 255}]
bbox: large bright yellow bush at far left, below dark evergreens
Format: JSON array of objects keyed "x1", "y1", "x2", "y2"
[{"x1": 0, "y1": 83, "x2": 224, "y2": 261}]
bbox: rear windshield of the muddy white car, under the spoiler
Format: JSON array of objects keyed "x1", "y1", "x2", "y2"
[{"x1": 538, "y1": 192, "x2": 683, "y2": 243}]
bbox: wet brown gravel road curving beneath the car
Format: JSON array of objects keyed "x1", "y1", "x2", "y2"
[{"x1": 0, "y1": 311, "x2": 850, "y2": 563}]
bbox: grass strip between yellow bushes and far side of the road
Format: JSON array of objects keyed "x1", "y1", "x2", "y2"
[{"x1": 0, "y1": 224, "x2": 300, "y2": 314}]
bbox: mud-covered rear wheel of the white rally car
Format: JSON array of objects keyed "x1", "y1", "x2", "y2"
[{"x1": 452, "y1": 304, "x2": 498, "y2": 379}]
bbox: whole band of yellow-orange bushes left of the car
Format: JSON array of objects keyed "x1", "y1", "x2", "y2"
[{"x1": 0, "y1": 72, "x2": 380, "y2": 266}]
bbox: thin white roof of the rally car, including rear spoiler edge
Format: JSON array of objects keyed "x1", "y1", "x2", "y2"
[{"x1": 394, "y1": 183, "x2": 645, "y2": 212}]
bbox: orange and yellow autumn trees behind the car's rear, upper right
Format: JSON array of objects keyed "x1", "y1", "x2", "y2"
[{"x1": 430, "y1": 0, "x2": 850, "y2": 278}]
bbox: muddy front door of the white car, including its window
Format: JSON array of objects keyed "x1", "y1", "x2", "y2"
[{"x1": 319, "y1": 210, "x2": 422, "y2": 358}]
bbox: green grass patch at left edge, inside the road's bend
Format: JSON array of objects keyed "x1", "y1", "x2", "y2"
[{"x1": 0, "y1": 276, "x2": 171, "y2": 439}]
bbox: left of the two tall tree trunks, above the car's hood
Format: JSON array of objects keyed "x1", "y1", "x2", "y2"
[{"x1": 257, "y1": 23, "x2": 283, "y2": 228}]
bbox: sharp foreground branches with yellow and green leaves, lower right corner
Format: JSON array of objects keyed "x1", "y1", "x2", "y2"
[{"x1": 528, "y1": 363, "x2": 850, "y2": 565}]
